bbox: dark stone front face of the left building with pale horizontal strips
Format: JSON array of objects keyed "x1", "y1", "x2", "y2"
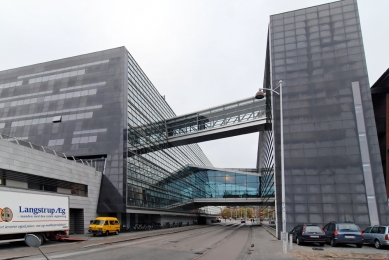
[{"x1": 0, "y1": 47, "x2": 128, "y2": 212}]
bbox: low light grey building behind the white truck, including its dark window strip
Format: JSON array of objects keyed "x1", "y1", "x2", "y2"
[{"x1": 0, "y1": 134, "x2": 102, "y2": 234}]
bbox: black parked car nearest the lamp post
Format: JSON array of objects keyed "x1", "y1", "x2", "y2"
[{"x1": 289, "y1": 224, "x2": 326, "y2": 246}]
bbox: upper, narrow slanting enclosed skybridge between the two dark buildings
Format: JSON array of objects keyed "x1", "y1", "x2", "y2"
[{"x1": 128, "y1": 98, "x2": 270, "y2": 156}]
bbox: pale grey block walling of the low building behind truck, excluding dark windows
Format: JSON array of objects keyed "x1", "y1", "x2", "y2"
[{"x1": 0, "y1": 140, "x2": 102, "y2": 232}]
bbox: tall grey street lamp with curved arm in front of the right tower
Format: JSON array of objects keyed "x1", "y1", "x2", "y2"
[{"x1": 255, "y1": 80, "x2": 288, "y2": 254}]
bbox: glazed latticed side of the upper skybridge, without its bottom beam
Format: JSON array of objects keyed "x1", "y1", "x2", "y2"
[{"x1": 128, "y1": 98, "x2": 267, "y2": 153}]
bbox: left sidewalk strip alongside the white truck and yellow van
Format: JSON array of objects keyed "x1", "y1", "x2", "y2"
[{"x1": 0, "y1": 225, "x2": 207, "y2": 260}]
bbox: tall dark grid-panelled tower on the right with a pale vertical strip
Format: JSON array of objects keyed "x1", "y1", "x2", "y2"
[{"x1": 259, "y1": 0, "x2": 389, "y2": 238}]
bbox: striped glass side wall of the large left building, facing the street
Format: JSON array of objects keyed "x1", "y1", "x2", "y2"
[{"x1": 127, "y1": 53, "x2": 212, "y2": 210}]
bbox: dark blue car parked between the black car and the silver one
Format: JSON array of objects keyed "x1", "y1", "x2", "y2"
[{"x1": 324, "y1": 221, "x2": 363, "y2": 248}]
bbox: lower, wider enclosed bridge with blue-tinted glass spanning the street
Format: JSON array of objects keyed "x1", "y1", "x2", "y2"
[{"x1": 141, "y1": 165, "x2": 274, "y2": 210}]
